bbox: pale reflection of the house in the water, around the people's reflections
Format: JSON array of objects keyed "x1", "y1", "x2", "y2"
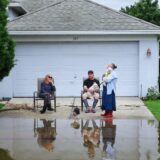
[{"x1": 0, "y1": 118, "x2": 159, "y2": 160}]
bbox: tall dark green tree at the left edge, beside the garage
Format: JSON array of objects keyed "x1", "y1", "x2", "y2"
[{"x1": 0, "y1": 0, "x2": 15, "y2": 81}]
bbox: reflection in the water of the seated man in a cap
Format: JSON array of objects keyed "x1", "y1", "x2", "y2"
[{"x1": 82, "y1": 120, "x2": 100, "y2": 158}]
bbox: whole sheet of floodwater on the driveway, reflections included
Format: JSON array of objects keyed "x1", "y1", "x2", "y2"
[{"x1": 0, "y1": 118, "x2": 160, "y2": 160}]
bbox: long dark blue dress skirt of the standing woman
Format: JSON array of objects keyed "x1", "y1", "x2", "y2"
[{"x1": 102, "y1": 86, "x2": 116, "y2": 111}]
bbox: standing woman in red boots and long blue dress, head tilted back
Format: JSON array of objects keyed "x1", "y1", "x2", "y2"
[{"x1": 101, "y1": 63, "x2": 117, "y2": 118}]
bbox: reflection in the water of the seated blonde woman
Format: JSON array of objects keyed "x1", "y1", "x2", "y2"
[{"x1": 37, "y1": 119, "x2": 56, "y2": 151}]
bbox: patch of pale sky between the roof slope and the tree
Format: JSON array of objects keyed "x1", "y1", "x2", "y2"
[{"x1": 93, "y1": 0, "x2": 160, "y2": 10}]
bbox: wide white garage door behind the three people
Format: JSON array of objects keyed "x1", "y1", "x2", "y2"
[{"x1": 13, "y1": 42, "x2": 138, "y2": 97}]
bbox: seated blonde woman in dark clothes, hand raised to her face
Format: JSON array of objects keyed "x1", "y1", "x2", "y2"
[{"x1": 39, "y1": 74, "x2": 56, "y2": 114}]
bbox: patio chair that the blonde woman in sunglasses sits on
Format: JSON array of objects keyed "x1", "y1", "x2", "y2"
[{"x1": 33, "y1": 78, "x2": 56, "y2": 112}]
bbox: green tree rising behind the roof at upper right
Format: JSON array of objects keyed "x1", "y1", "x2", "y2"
[{"x1": 121, "y1": 0, "x2": 160, "y2": 26}]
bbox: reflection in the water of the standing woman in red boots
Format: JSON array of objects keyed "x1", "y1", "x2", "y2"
[{"x1": 102, "y1": 119, "x2": 116, "y2": 160}]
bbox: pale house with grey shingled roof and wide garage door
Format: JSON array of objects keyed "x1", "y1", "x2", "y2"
[{"x1": 0, "y1": 0, "x2": 160, "y2": 97}]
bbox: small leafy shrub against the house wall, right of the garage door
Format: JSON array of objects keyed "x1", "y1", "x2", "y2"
[{"x1": 145, "y1": 86, "x2": 160, "y2": 100}]
